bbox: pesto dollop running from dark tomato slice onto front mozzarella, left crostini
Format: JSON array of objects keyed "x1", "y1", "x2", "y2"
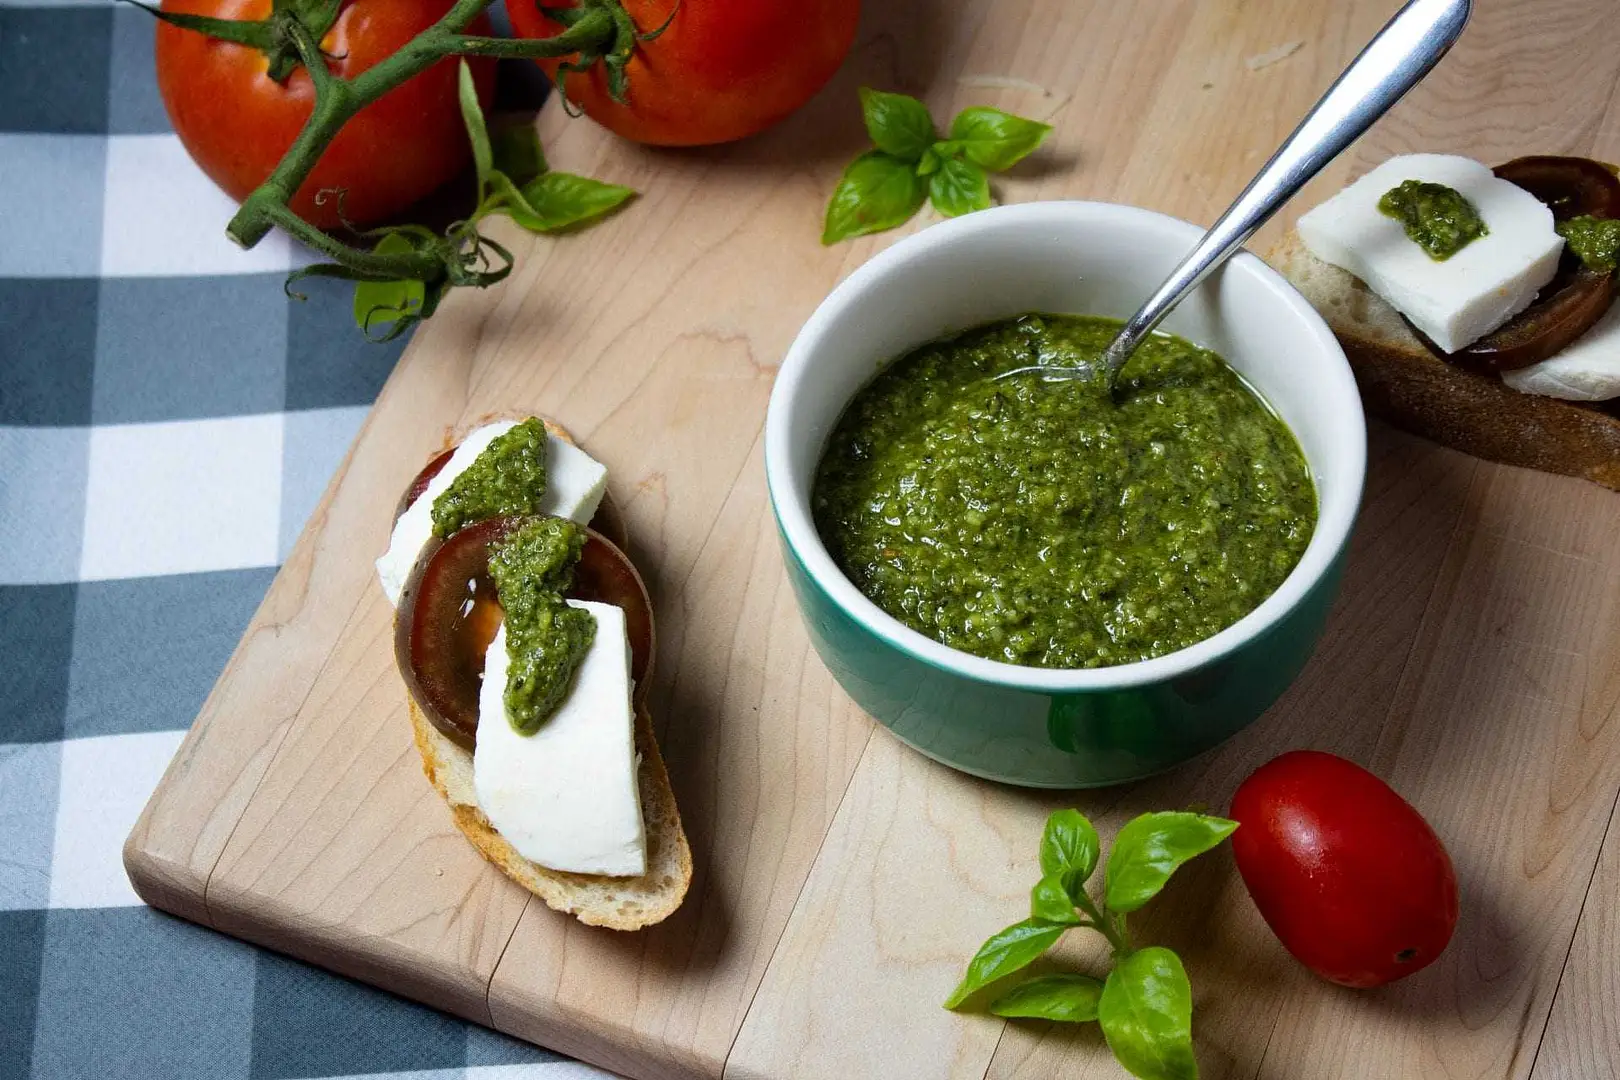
[{"x1": 486, "y1": 514, "x2": 596, "y2": 735}]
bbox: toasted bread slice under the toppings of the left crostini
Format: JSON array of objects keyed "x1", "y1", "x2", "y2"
[{"x1": 407, "y1": 413, "x2": 692, "y2": 929}]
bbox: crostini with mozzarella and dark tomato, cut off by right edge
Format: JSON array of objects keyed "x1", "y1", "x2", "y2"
[{"x1": 1268, "y1": 154, "x2": 1620, "y2": 489}]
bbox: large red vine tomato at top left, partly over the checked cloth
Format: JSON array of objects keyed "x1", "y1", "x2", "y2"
[{"x1": 157, "y1": 0, "x2": 494, "y2": 228}]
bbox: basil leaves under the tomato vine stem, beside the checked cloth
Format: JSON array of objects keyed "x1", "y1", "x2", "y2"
[{"x1": 355, "y1": 60, "x2": 635, "y2": 342}]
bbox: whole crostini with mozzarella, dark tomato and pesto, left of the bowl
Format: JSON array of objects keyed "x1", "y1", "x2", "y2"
[{"x1": 377, "y1": 418, "x2": 692, "y2": 929}]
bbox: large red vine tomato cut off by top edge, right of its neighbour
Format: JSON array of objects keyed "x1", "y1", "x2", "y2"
[{"x1": 507, "y1": 0, "x2": 860, "y2": 146}]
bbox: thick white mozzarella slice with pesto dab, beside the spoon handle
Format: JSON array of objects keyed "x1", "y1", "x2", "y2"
[{"x1": 1298, "y1": 154, "x2": 1563, "y2": 353}]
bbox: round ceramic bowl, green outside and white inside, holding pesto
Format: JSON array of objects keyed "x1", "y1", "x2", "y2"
[{"x1": 765, "y1": 202, "x2": 1367, "y2": 787}]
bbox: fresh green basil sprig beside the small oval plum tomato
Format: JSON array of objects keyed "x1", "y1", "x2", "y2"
[{"x1": 944, "y1": 810, "x2": 1238, "y2": 1080}]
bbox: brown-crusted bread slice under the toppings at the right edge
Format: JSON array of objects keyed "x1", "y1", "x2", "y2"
[{"x1": 1267, "y1": 230, "x2": 1620, "y2": 491}]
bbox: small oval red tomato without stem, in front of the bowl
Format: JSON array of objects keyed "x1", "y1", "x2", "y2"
[{"x1": 1231, "y1": 750, "x2": 1456, "y2": 986}]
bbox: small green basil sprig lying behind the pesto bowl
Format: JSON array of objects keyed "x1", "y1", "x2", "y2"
[{"x1": 821, "y1": 86, "x2": 1051, "y2": 244}]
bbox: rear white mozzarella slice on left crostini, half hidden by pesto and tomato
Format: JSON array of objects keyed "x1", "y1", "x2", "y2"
[{"x1": 377, "y1": 419, "x2": 608, "y2": 607}]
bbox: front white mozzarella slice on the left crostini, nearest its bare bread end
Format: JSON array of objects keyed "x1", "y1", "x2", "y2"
[{"x1": 473, "y1": 601, "x2": 646, "y2": 878}]
